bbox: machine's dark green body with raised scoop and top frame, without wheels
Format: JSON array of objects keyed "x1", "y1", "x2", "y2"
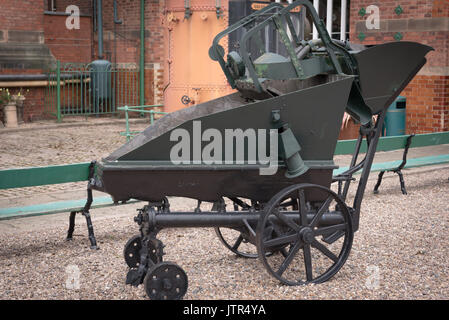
[{"x1": 93, "y1": 1, "x2": 432, "y2": 208}]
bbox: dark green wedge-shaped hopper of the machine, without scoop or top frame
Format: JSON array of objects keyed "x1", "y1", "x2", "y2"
[{"x1": 94, "y1": 75, "x2": 353, "y2": 201}]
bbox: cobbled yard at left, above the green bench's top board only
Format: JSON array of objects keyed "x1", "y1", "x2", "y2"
[{"x1": 0, "y1": 119, "x2": 148, "y2": 169}]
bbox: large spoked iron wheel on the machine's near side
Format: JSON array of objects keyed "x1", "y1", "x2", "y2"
[{"x1": 256, "y1": 184, "x2": 353, "y2": 285}]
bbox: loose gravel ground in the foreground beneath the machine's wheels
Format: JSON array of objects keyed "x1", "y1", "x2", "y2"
[{"x1": 0, "y1": 165, "x2": 449, "y2": 300}]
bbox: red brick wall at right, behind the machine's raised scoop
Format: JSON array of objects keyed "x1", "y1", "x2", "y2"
[{"x1": 350, "y1": 0, "x2": 449, "y2": 133}]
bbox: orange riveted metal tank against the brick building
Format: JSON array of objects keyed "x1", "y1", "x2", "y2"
[{"x1": 164, "y1": 0, "x2": 232, "y2": 112}]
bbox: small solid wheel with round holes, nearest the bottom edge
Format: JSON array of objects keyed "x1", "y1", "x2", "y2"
[{"x1": 143, "y1": 262, "x2": 188, "y2": 300}]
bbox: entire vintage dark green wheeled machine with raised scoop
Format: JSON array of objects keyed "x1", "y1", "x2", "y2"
[{"x1": 79, "y1": 0, "x2": 432, "y2": 299}]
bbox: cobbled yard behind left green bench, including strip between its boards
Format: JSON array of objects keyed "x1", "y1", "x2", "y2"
[{"x1": 0, "y1": 118, "x2": 148, "y2": 201}]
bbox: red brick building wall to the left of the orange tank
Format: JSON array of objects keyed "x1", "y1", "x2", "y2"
[{"x1": 0, "y1": 0, "x2": 164, "y2": 121}]
